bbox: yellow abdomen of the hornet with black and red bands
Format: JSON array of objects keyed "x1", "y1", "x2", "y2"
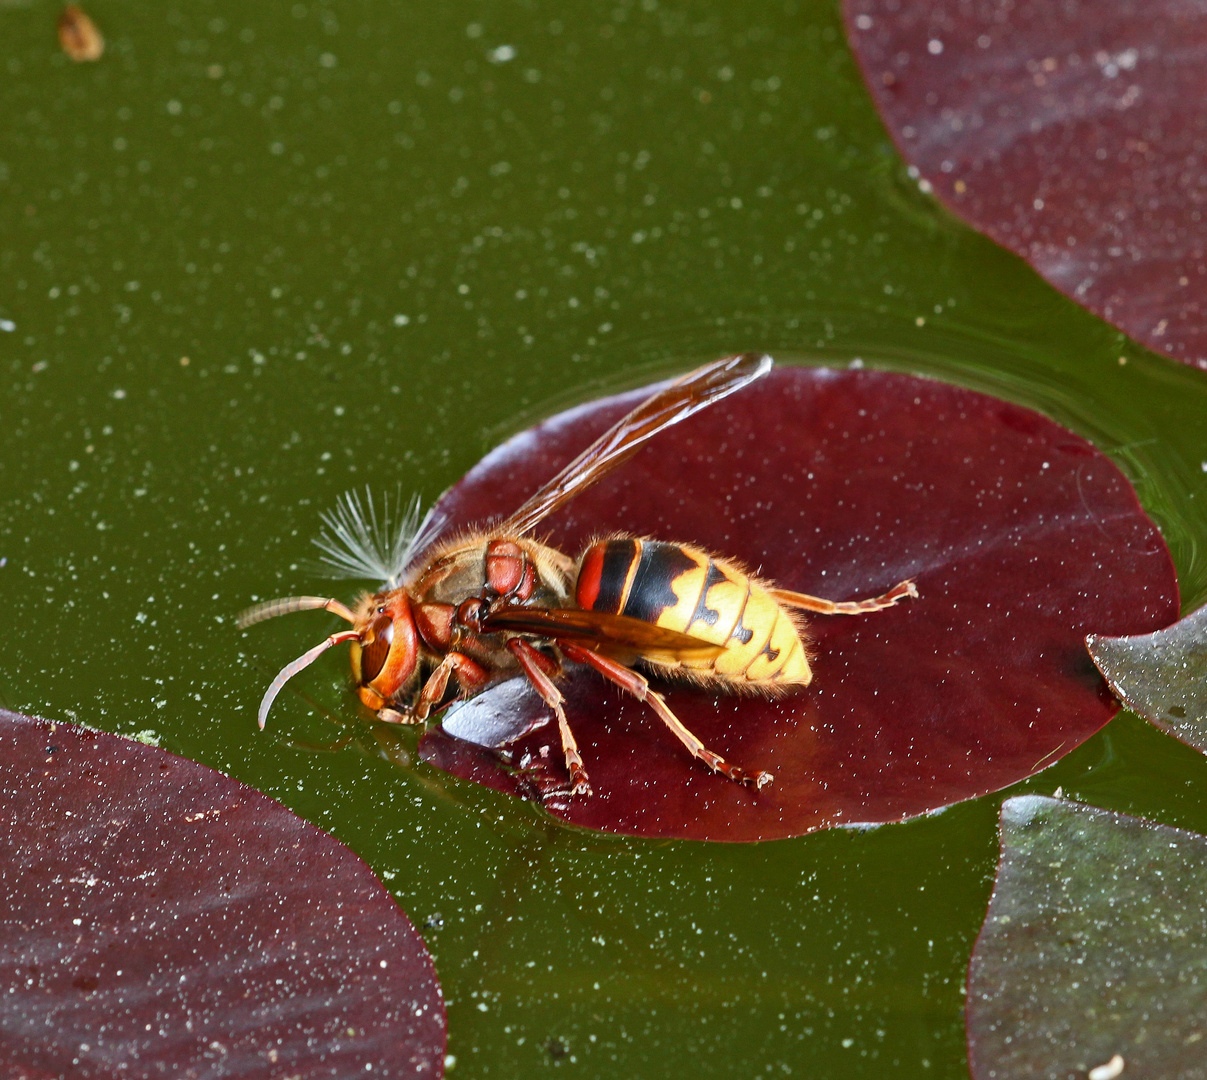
[{"x1": 575, "y1": 538, "x2": 812, "y2": 687}]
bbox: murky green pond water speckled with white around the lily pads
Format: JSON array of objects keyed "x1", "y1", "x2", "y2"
[{"x1": 0, "y1": 0, "x2": 1207, "y2": 1080}]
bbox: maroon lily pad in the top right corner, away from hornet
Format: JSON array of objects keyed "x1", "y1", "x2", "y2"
[{"x1": 844, "y1": 0, "x2": 1207, "y2": 368}]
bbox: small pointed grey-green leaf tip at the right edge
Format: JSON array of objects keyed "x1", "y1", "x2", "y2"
[{"x1": 1085, "y1": 607, "x2": 1207, "y2": 753}]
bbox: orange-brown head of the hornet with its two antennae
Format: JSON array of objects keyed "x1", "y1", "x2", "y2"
[{"x1": 239, "y1": 589, "x2": 419, "y2": 728}]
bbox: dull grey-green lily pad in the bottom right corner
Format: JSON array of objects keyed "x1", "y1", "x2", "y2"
[{"x1": 967, "y1": 795, "x2": 1207, "y2": 1080}]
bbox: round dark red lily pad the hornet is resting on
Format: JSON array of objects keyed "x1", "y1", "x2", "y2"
[{"x1": 420, "y1": 368, "x2": 1178, "y2": 840}]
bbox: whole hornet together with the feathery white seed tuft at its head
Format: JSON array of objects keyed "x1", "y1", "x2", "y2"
[{"x1": 239, "y1": 354, "x2": 917, "y2": 796}]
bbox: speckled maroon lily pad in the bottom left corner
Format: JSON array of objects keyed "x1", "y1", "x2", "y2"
[{"x1": 0, "y1": 711, "x2": 445, "y2": 1080}]
